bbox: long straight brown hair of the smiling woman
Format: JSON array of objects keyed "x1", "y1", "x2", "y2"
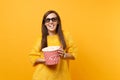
[{"x1": 40, "y1": 10, "x2": 66, "y2": 50}]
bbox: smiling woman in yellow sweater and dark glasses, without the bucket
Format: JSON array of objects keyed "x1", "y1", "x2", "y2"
[{"x1": 29, "y1": 10, "x2": 76, "y2": 80}]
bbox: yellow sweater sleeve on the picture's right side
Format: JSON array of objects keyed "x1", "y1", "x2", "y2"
[{"x1": 66, "y1": 32, "x2": 77, "y2": 58}]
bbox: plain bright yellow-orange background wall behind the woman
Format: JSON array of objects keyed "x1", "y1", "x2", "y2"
[{"x1": 0, "y1": 0, "x2": 120, "y2": 80}]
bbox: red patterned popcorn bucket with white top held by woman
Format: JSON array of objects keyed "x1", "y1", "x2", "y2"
[{"x1": 42, "y1": 46, "x2": 60, "y2": 65}]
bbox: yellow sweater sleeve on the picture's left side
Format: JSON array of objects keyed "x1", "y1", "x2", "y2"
[{"x1": 29, "y1": 39, "x2": 43, "y2": 64}]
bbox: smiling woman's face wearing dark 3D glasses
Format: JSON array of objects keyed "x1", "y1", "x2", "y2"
[{"x1": 45, "y1": 13, "x2": 58, "y2": 33}]
